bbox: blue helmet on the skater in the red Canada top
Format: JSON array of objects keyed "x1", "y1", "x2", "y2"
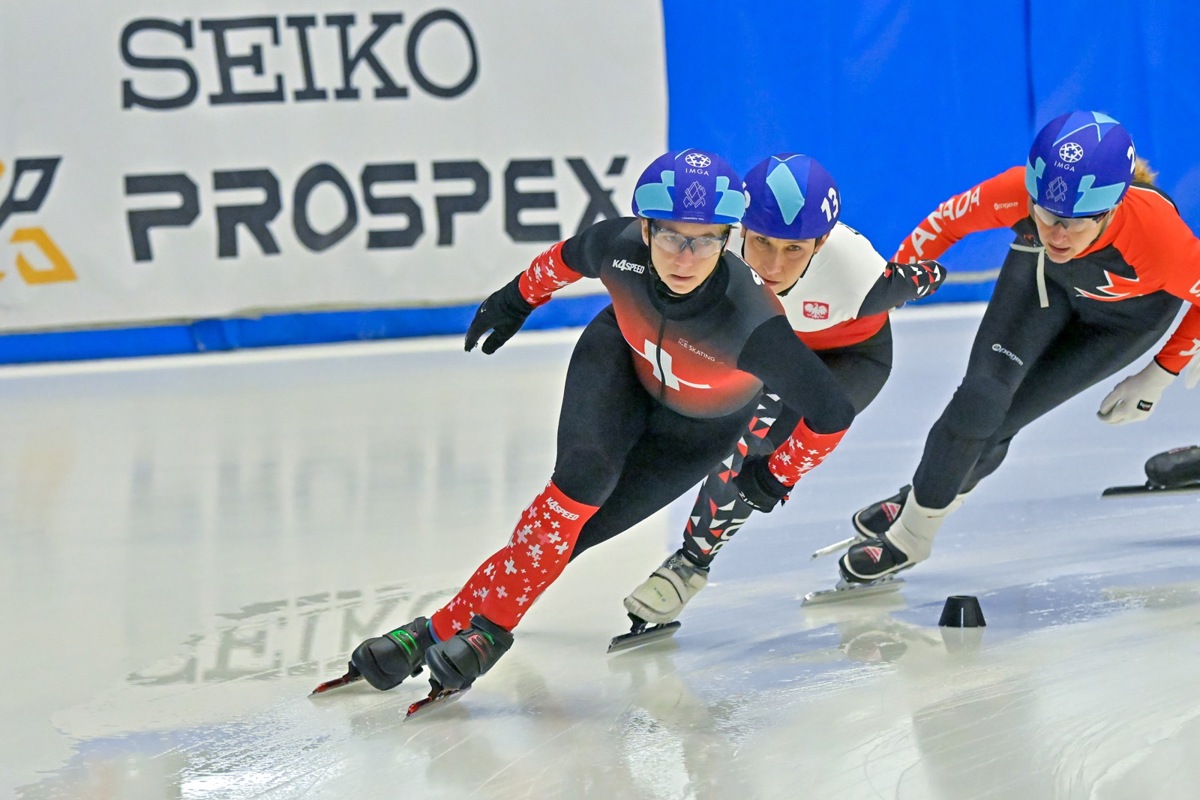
[{"x1": 1025, "y1": 112, "x2": 1134, "y2": 217}]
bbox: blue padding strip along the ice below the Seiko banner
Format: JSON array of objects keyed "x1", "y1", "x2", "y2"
[{"x1": 0, "y1": 281, "x2": 995, "y2": 365}]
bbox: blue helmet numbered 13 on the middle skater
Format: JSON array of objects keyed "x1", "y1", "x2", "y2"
[{"x1": 742, "y1": 154, "x2": 841, "y2": 239}]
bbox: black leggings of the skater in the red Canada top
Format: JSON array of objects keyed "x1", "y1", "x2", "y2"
[{"x1": 912, "y1": 244, "x2": 1182, "y2": 509}]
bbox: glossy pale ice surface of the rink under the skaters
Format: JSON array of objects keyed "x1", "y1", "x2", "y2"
[{"x1": 0, "y1": 306, "x2": 1200, "y2": 800}]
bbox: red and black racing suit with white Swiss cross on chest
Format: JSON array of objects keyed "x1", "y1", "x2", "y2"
[{"x1": 432, "y1": 218, "x2": 854, "y2": 638}]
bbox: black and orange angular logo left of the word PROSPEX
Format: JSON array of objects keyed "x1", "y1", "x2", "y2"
[{"x1": 0, "y1": 157, "x2": 76, "y2": 285}]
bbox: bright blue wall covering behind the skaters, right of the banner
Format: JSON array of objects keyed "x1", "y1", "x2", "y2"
[{"x1": 664, "y1": 0, "x2": 1200, "y2": 275}]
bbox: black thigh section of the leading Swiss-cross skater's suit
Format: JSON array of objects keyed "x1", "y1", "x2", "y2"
[{"x1": 553, "y1": 307, "x2": 756, "y2": 558}]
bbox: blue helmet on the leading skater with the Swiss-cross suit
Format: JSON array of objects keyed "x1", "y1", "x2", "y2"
[{"x1": 634, "y1": 150, "x2": 746, "y2": 225}]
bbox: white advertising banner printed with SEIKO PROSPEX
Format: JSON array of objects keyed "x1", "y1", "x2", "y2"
[{"x1": 0, "y1": 0, "x2": 667, "y2": 332}]
